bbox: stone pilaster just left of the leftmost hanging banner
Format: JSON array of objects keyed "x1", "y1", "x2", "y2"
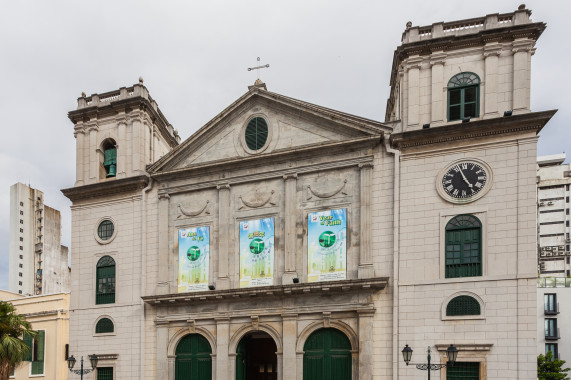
[{"x1": 155, "y1": 194, "x2": 170, "y2": 294}]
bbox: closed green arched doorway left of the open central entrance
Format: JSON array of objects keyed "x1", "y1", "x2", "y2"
[{"x1": 175, "y1": 334, "x2": 212, "y2": 380}]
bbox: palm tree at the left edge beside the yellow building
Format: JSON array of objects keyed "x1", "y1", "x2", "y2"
[{"x1": 0, "y1": 301, "x2": 36, "y2": 380}]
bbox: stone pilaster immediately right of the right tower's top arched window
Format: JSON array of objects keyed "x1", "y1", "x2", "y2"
[{"x1": 480, "y1": 42, "x2": 502, "y2": 119}]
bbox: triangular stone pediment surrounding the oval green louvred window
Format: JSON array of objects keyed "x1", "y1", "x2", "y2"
[{"x1": 149, "y1": 88, "x2": 390, "y2": 173}]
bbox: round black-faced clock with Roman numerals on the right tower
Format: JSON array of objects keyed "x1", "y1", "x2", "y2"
[{"x1": 436, "y1": 158, "x2": 492, "y2": 203}]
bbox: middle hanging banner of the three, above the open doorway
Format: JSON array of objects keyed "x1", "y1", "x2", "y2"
[{"x1": 240, "y1": 218, "x2": 274, "y2": 288}]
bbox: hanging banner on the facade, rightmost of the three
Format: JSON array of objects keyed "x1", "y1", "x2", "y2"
[{"x1": 307, "y1": 208, "x2": 347, "y2": 282}]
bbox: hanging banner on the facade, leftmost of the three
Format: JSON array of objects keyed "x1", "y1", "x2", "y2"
[{"x1": 179, "y1": 227, "x2": 210, "y2": 293}]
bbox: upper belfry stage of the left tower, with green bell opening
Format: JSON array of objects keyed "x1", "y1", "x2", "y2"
[{"x1": 68, "y1": 78, "x2": 180, "y2": 187}]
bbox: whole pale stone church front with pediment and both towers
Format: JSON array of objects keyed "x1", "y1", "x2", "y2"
[{"x1": 63, "y1": 6, "x2": 555, "y2": 380}]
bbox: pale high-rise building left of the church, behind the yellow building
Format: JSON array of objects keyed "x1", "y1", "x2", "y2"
[{"x1": 9, "y1": 183, "x2": 70, "y2": 295}]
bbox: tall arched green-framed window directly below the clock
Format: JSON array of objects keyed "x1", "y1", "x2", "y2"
[{"x1": 445, "y1": 215, "x2": 482, "y2": 278}]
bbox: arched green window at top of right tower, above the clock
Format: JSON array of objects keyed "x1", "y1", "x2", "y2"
[{"x1": 447, "y1": 72, "x2": 480, "y2": 121}]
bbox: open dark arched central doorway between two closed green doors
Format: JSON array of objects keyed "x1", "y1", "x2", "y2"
[{"x1": 236, "y1": 331, "x2": 278, "y2": 380}]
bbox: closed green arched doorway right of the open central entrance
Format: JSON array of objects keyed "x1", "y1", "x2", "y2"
[{"x1": 303, "y1": 328, "x2": 351, "y2": 380}]
